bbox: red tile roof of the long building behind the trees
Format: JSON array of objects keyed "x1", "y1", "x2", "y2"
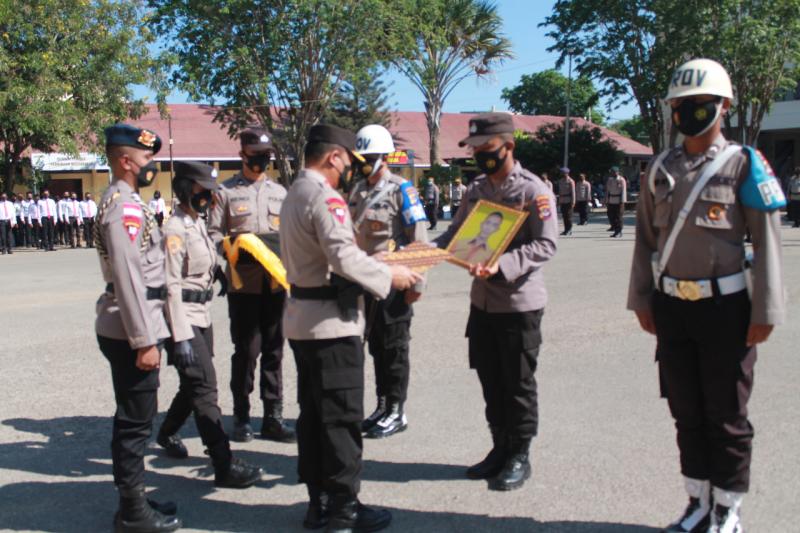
[{"x1": 126, "y1": 104, "x2": 653, "y2": 166}]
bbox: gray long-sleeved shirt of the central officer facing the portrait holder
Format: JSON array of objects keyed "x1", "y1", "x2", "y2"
[{"x1": 280, "y1": 169, "x2": 392, "y2": 340}]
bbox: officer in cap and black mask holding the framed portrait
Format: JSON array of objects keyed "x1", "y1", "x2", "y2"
[{"x1": 435, "y1": 113, "x2": 558, "y2": 490}]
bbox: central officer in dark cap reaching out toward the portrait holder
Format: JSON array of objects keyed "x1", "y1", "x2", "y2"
[{"x1": 281, "y1": 124, "x2": 422, "y2": 531}]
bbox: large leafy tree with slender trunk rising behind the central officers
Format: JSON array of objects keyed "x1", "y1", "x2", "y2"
[{"x1": 151, "y1": 0, "x2": 408, "y2": 183}]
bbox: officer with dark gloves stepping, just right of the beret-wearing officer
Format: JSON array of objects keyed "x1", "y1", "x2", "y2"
[{"x1": 157, "y1": 161, "x2": 262, "y2": 488}]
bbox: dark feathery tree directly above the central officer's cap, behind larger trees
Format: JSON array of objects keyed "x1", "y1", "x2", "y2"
[{"x1": 323, "y1": 68, "x2": 392, "y2": 131}]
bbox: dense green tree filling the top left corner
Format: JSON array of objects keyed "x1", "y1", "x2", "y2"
[{"x1": 0, "y1": 0, "x2": 157, "y2": 191}]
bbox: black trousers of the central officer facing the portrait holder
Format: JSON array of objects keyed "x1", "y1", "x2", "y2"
[{"x1": 289, "y1": 337, "x2": 364, "y2": 497}]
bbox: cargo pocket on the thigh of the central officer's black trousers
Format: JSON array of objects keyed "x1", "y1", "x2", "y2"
[{"x1": 320, "y1": 367, "x2": 364, "y2": 424}]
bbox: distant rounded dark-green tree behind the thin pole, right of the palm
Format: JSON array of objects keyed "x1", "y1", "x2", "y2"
[{"x1": 502, "y1": 69, "x2": 603, "y2": 124}]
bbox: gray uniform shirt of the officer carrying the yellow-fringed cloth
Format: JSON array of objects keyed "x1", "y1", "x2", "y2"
[{"x1": 208, "y1": 174, "x2": 286, "y2": 294}]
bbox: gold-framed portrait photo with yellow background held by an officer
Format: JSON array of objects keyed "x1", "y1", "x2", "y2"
[{"x1": 447, "y1": 200, "x2": 528, "y2": 268}]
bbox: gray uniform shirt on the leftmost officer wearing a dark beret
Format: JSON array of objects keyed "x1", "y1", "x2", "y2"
[{"x1": 95, "y1": 181, "x2": 169, "y2": 349}]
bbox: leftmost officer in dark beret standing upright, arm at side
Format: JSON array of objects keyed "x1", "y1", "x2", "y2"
[{"x1": 95, "y1": 124, "x2": 181, "y2": 532}]
